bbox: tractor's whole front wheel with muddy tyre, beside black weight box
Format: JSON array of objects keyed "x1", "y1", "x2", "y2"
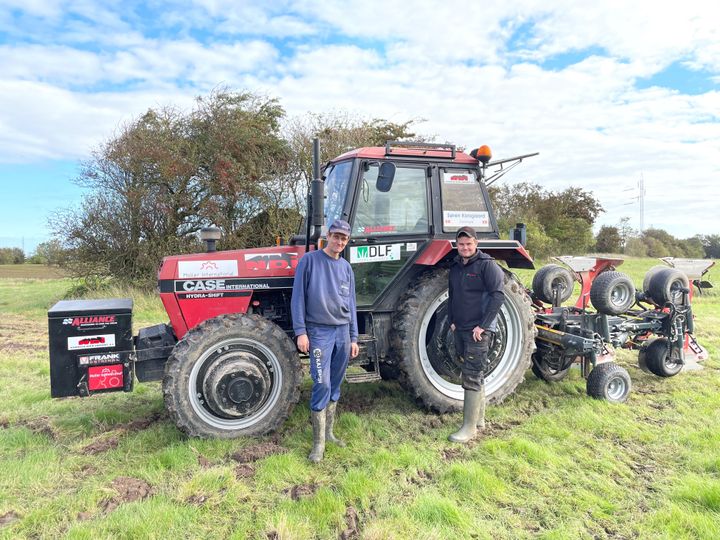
[{"x1": 163, "y1": 314, "x2": 302, "y2": 439}]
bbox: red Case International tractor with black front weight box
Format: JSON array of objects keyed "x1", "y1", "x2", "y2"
[{"x1": 49, "y1": 142, "x2": 708, "y2": 437}]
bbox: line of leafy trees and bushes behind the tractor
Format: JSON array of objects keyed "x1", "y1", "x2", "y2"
[{"x1": 9, "y1": 89, "x2": 720, "y2": 285}]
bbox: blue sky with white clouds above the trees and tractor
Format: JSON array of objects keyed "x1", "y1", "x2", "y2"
[{"x1": 0, "y1": 0, "x2": 720, "y2": 251}]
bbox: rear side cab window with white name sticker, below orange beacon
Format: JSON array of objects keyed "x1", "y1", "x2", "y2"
[{"x1": 440, "y1": 169, "x2": 492, "y2": 232}]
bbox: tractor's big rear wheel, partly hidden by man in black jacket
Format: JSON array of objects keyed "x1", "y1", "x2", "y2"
[{"x1": 391, "y1": 269, "x2": 536, "y2": 413}]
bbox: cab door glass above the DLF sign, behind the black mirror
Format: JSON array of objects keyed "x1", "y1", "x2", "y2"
[{"x1": 353, "y1": 163, "x2": 429, "y2": 236}]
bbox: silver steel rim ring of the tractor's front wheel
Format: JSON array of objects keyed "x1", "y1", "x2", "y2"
[{"x1": 187, "y1": 338, "x2": 283, "y2": 430}]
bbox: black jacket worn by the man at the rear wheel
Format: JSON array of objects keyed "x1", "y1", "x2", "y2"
[{"x1": 448, "y1": 250, "x2": 505, "y2": 331}]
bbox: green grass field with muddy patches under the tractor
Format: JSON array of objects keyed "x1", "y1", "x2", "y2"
[{"x1": 0, "y1": 259, "x2": 720, "y2": 539}]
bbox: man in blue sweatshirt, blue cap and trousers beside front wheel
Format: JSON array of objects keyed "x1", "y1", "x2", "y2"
[{"x1": 290, "y1": 219, "x2": 359, "y2": 463}]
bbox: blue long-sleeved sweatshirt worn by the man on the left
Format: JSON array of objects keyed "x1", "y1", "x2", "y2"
[{"x1": 290, "y1": 249, "x2": 358, "y2": 343}]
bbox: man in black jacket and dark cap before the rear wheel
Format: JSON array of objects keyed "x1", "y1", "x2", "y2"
[{"x1": 448, "y1": 227, "x2": 505, "y2": 443}]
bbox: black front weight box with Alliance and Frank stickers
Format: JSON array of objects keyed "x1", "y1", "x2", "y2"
[{"x1": 48, "y1": 298, "x2": 134, "y2": 397}]
